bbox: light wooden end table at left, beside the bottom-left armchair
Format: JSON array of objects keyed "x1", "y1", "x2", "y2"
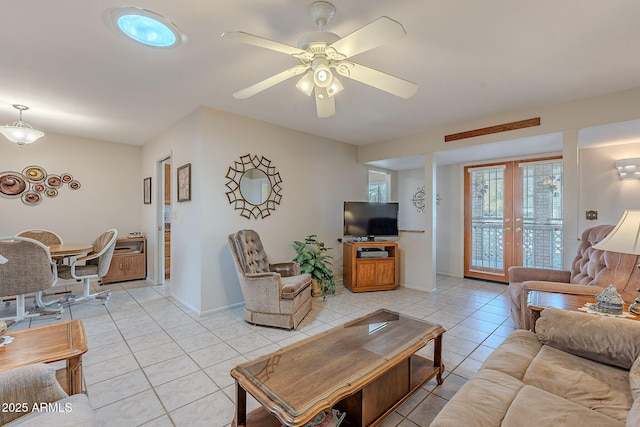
[{"x1": 0, "y1": 320, "x2": 87, "y2": 395}]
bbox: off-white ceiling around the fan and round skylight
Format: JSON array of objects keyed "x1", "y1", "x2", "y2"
[{"x1": 0, "y1": 0, "x2": 640, "y2": 150}]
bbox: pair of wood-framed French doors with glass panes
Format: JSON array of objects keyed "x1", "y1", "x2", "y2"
[{"x1": 464, "y1": 158, "x2": 562, "y2": 282}]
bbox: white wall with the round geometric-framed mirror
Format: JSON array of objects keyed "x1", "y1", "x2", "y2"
[{"x1": 143, "y1": 107, "x2": 367, "y2": 313}]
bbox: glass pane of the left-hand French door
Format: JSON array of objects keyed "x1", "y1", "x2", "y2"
[{"x1": 469, "y1": 166, "x2": 504, "y2": 271}]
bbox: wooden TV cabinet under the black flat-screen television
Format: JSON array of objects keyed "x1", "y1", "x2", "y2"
[{"x1": 342, "y1": 242, "x2": 398, "y2": 292}]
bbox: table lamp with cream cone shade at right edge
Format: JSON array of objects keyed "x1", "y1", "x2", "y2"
[{"x1": 593, "y1": 210, "x2": 640, "y2": 314}]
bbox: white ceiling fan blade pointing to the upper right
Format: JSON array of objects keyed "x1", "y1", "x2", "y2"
[{"x1": 326, "y1": 16, "x2": 407, "y2": 59}]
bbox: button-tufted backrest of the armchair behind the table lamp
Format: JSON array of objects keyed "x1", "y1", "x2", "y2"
[{"x1": 570, "y1": 225, "x2": 640, "y2": 301}]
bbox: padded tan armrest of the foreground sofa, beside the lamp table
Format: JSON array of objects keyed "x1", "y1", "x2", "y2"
[{"x1": 536, "y1": 308, "x2": 640, "y2": 370}]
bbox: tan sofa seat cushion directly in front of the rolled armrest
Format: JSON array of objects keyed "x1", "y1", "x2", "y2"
[{"x1": 522, "y1": 346, "x2": 633, "y2": 425}]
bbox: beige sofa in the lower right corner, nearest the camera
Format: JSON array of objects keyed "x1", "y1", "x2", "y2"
[{"x1": 431, "y1": 308, "x2": 640, "y2": 427}]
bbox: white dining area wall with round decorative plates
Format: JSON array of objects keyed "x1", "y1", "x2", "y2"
[{"x1": 0, "y1": 133, "x2": 143, "y2": 243}]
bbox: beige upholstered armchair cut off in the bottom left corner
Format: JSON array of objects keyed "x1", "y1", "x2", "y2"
[{"x1": 0, "y1": 363, "x2": 98, "y2": 427}]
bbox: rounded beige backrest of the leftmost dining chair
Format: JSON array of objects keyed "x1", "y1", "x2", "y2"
[{"x1": 0, "y1": 237, "x2": 57, "y2": 297}]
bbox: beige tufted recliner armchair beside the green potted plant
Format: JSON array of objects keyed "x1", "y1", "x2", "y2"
[{"x1": 229, "y1": 230, "x2": 311, "y2": 329}]
